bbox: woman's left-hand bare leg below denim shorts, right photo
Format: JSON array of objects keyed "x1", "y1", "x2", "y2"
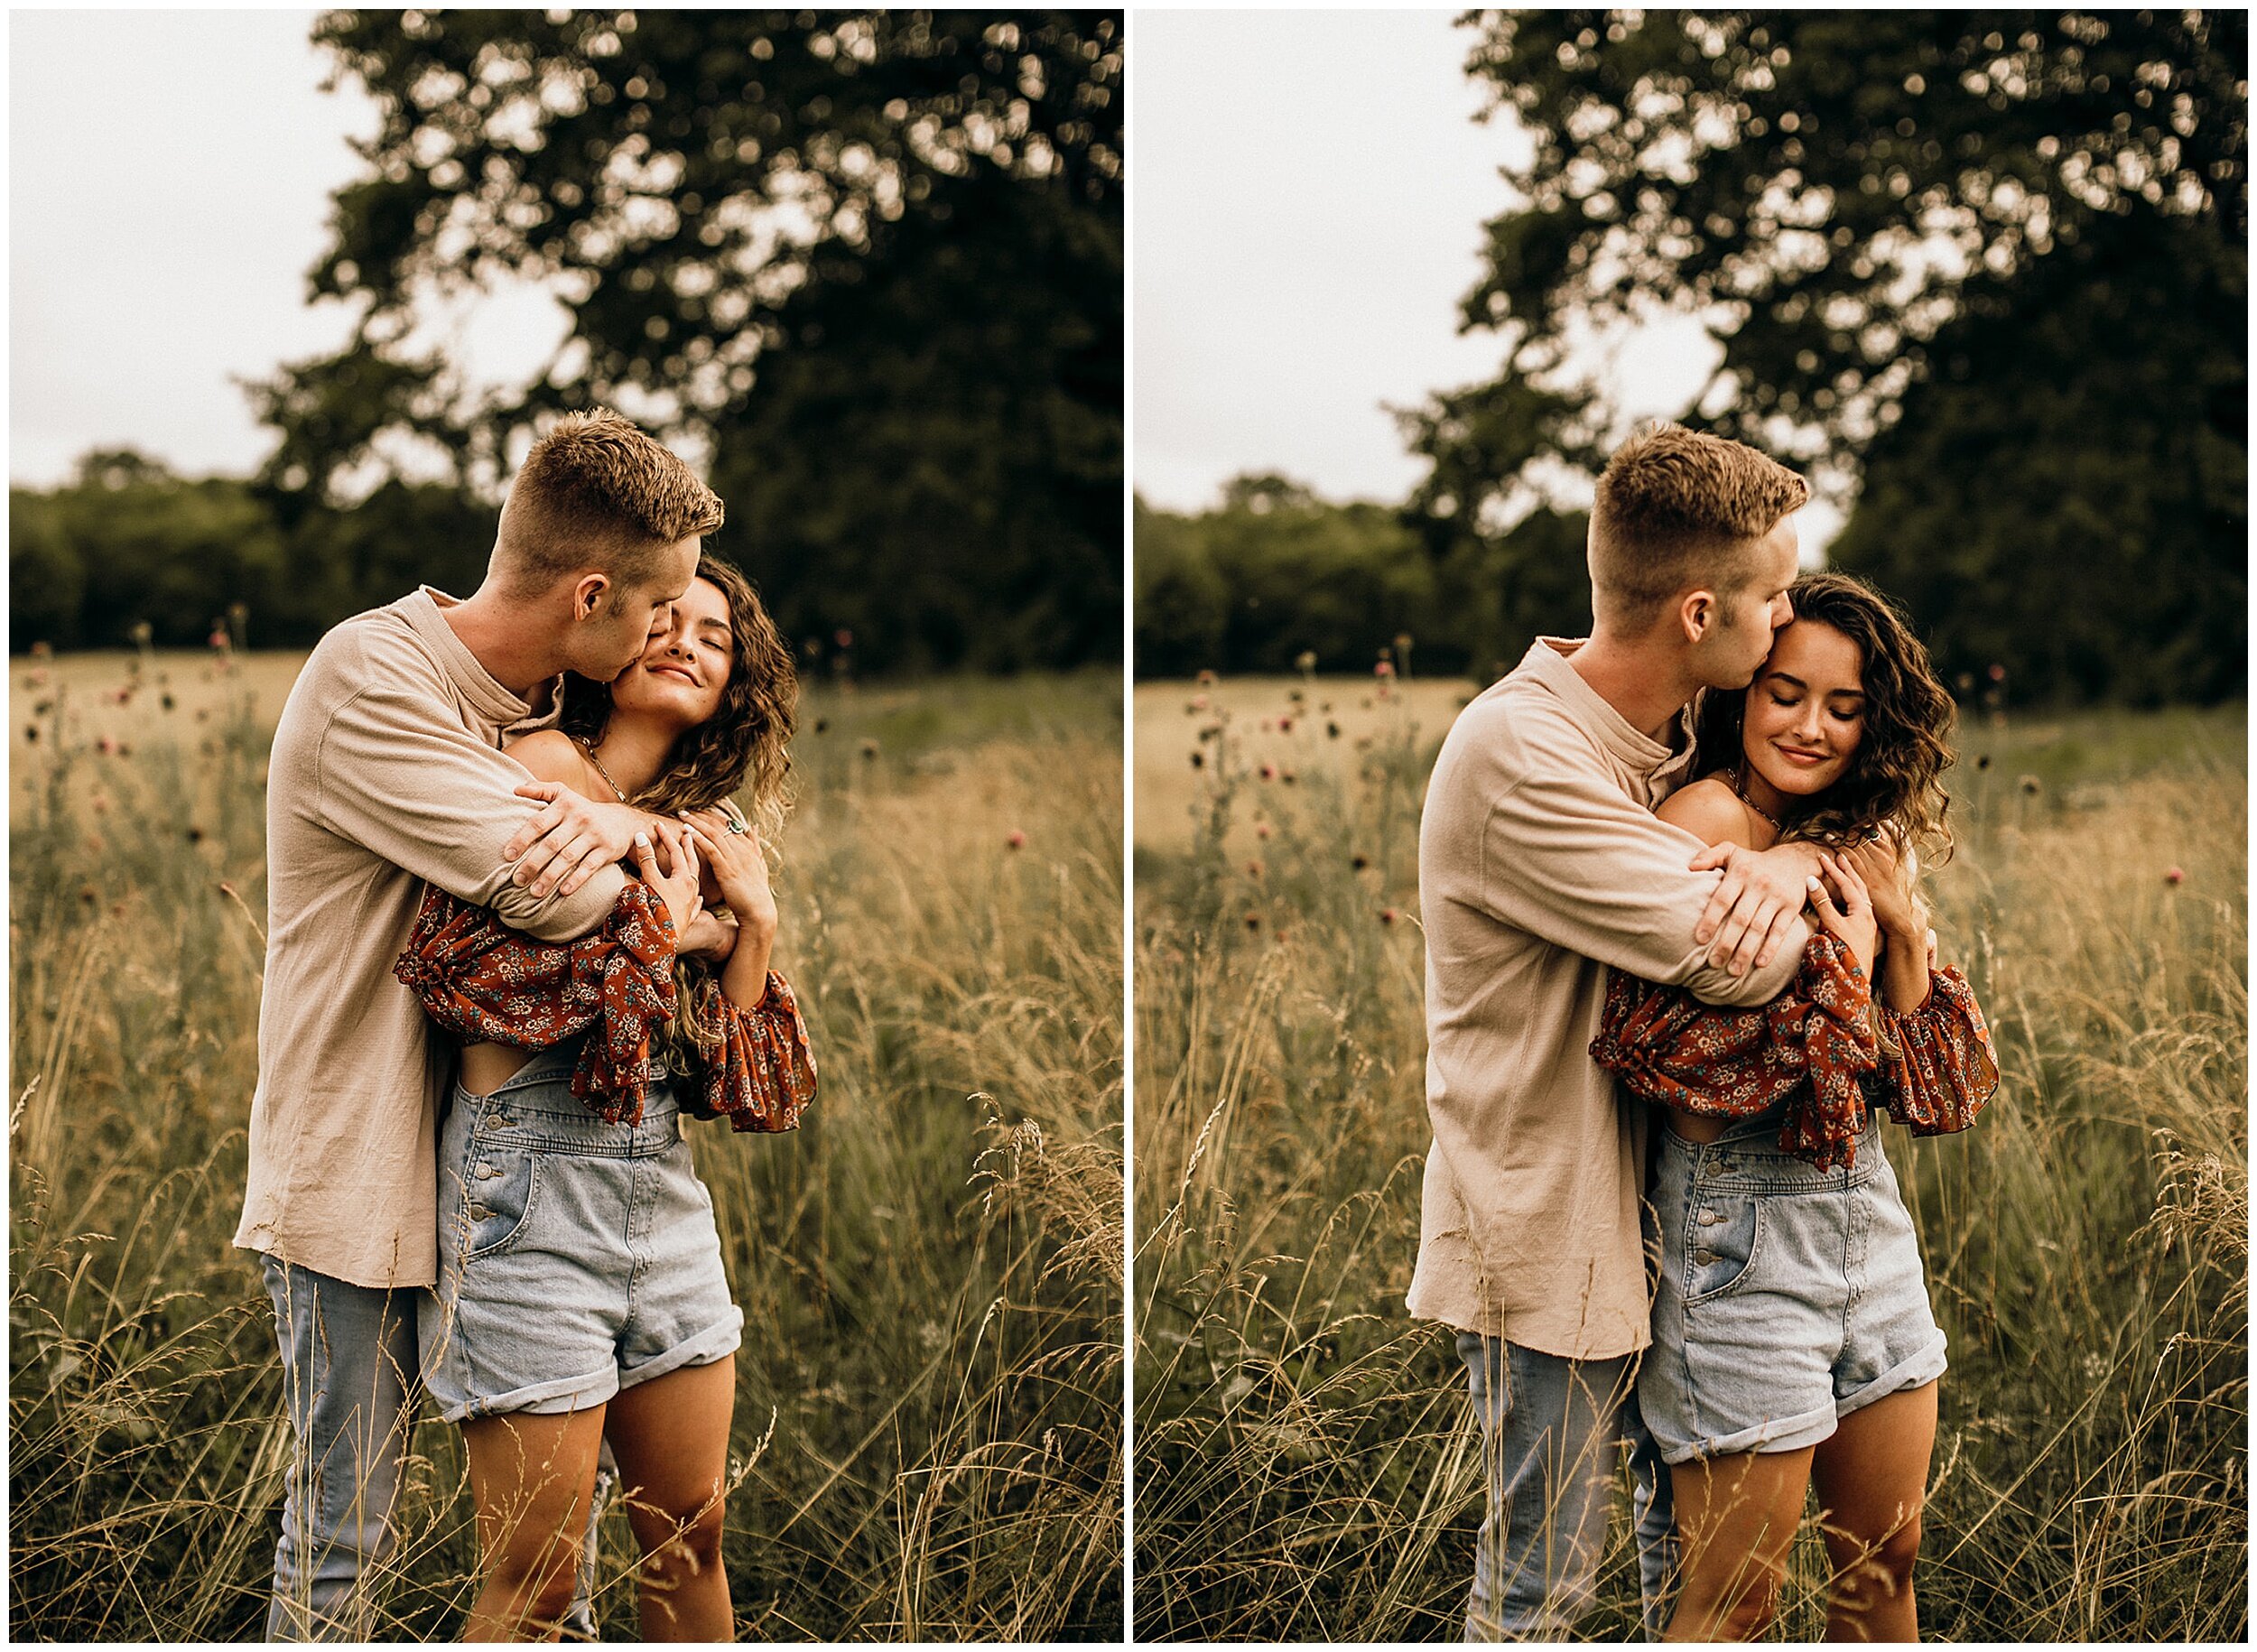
[{"x1": 1664, "y1": 1447, "x2": 1810, "y2": 1641}]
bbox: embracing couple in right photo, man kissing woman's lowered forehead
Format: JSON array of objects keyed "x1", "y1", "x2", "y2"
[{"x1": 1411, "y1": 424, "x2": 1998, "y2": 1641}]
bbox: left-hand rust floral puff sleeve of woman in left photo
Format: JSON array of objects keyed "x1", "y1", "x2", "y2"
[{"x1": 393, "y1": 878, "x2": 675, "y2": 1124}]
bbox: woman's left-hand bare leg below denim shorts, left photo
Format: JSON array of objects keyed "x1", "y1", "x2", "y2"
[{"x1": 463, "y1": 1406, "x2": 603, "y2": 1641}]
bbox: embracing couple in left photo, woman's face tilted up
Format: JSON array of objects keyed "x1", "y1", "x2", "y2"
[{"x1": 235, "y1": 411, "x2": 815, "y2": 1641}]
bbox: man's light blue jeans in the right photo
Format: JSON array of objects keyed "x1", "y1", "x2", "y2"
[{"x1": 1458, "y1": 1332, "x2": 1677, "y2": 1641}]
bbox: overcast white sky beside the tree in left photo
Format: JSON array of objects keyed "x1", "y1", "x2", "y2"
[{"x1": 9, "y1": 12, "x2": 573, "y2": 486}]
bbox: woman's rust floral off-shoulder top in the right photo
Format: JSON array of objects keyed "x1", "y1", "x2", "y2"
[{"x1": 1592, "y1": 930, "x2": 1998, "y2": 1169}]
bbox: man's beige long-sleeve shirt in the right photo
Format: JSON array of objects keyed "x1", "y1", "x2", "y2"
[{"x1": 1411, "y1": 636, "x2": 1808, "y2": 1359}]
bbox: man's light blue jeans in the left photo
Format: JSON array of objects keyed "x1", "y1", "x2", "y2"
[{"x1": 262, "y1": 1258, "x2": 612, "y2": 1641}]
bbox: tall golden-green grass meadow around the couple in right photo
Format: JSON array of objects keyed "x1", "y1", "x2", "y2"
[{"x1": 1136, "y1": 677, "x2": 2248, "y2": 1646}]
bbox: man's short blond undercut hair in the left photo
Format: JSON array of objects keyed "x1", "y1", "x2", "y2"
[{"x1": 495, "y1": 409, "x2": 722, "y2": 603}]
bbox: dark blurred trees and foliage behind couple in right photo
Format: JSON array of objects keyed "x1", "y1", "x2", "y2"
[{"x1": 1136, "y1": 12, "x2": 2248, "y2": 704}]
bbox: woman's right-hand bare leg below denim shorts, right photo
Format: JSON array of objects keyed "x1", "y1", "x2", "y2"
[{"x1": 1813, "y1": 1384, "x2": 1937, "y2": 1641}]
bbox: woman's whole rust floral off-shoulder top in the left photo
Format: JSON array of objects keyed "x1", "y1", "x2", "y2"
[{"x1": 393, "y1": 878, "x2": 815, "y2": 1131}]
